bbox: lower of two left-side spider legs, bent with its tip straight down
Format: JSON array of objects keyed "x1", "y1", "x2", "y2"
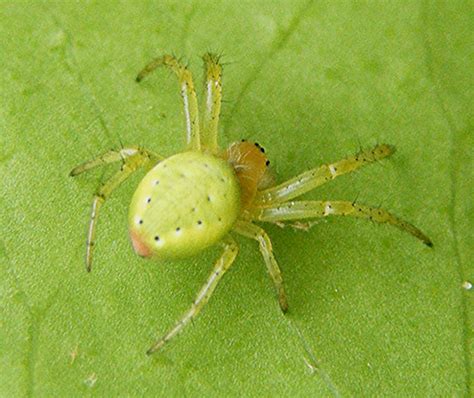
[{"x1": 80, "y1": 152, "x2": 153, "y2": 272}]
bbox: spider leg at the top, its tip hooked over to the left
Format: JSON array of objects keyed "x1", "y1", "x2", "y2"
[{"x1": 136, "y1": 55, "x2": 201, "y2": 150}]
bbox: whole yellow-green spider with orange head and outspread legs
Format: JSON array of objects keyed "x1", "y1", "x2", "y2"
[{"x1": 70, "y1": 53, "x2": 433, "y2": 354}]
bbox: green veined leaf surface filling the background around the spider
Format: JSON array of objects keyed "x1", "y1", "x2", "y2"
[{"x1": 0, "y1": 1, "x2": 474, "y2": 397}]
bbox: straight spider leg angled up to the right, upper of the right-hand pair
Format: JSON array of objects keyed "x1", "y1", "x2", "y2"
[{"x1": 255, "y1": 144, "x2": 395, "y2": 206}]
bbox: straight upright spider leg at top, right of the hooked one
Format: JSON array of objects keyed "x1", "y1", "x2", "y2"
[{"x1": 201, "y1": 53, "x2": 222, "y2": 152}]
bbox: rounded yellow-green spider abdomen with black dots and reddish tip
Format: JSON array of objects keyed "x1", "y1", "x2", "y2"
[{"x1": 129, "y1": 152, "x2": 240, "y2": 258}]
